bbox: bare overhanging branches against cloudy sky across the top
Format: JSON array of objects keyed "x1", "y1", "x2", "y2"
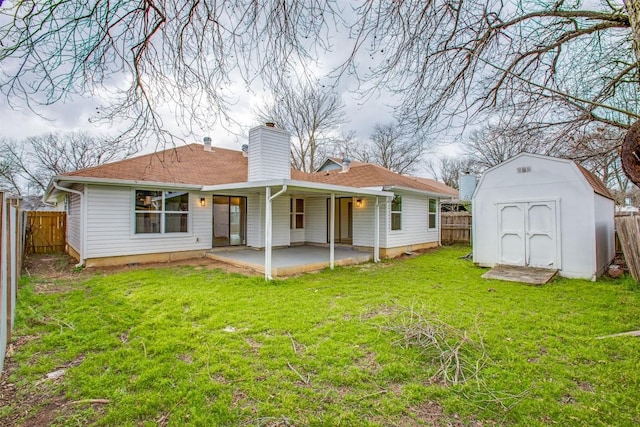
[{"x1": 0, "y1": 0, "x2": 640, "y2": 181}]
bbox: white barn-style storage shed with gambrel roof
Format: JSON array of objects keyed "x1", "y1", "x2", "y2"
[{"x1": 473, "y1": 153, "x2": 615, "y2": 280}]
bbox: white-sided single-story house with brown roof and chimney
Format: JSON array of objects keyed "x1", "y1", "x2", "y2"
[{"x1": 45, "y1": 126, "x2": 456, "y2": 277}]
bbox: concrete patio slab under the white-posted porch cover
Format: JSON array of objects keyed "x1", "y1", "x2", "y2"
[{"x1": 207, "y1": 245, "x2": 373, "y2": 277}]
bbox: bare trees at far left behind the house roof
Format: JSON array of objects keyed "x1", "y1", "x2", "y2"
[{"x1": 0, "y1": 132, "x2": 137, "y2": 195}]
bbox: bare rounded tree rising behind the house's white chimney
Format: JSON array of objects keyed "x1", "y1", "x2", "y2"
[{"x1": 257, "y1": 84, "x2": 345, "y2": 172}]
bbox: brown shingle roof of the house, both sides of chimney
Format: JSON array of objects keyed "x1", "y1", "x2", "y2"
[{"x1": 58, "y1": 144, "x2": 457, "y2": 196}]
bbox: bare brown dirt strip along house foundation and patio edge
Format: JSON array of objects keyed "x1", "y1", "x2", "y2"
[{"x1": 23, "y1": 254, "x2": 261, "y2": 286}]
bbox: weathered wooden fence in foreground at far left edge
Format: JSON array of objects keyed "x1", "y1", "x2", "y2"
[{"x1": 0, "y1": 191, "x2": 22, "y2": 373}]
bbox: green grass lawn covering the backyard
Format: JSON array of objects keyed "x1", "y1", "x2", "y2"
[{"x1": 0, "y1": 247, "x2": 640, "y2": 426}]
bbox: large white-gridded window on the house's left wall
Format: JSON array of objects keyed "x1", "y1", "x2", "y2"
[{"x1": 135, "y1": 190, "x2": 189, "y2": 234}]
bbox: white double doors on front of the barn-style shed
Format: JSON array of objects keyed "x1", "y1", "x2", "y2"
[{"x1": 498, "y1": 201, "x2": 560, "y2": 269}]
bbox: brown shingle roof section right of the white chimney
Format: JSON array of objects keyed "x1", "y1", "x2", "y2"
[{"x1": 302, "y1": 162, "x2": 458, "y2": 196}]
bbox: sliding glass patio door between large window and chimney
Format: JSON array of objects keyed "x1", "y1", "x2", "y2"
[{"x1": 213, "y1": 196, "x2": 247, "y2": 247}]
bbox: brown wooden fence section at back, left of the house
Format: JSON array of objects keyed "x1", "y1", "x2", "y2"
[{"x1": 25, "y1": 211, "x2": 67, "y2": 254}]
